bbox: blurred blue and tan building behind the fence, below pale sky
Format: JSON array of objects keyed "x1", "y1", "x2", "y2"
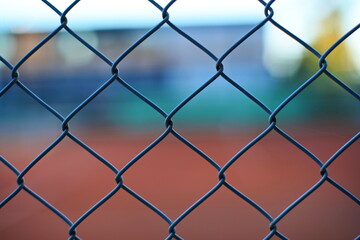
[{"x1": 0, "y1": 25, "x2": 269, "y2": 128}]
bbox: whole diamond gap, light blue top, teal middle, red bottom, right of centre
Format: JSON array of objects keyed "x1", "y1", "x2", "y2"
[{"x1": 172, "y1": 77, "x2": 268, "y2": 166}]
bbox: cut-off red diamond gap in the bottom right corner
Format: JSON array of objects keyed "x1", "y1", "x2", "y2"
[{"x1": 278, "y1": 182, "x2": 360, "y2": 239}]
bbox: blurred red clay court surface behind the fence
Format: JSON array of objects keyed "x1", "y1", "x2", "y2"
[{"x1": 0, "y1": 128, "x2": 360, "y2": 240}]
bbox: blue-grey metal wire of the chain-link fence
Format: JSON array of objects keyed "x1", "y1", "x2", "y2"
[{"x1": 0, "y1": 0, "x2": 360, "y2": 240}]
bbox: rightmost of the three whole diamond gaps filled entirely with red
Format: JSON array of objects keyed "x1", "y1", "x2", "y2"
[{"x1": 225, "y1": 132, "x2": 320, "y2": 216}]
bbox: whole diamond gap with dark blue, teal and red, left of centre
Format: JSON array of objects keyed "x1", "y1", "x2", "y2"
[{"x1": 69, "y1": 82, "x2": 165, "y2": 169}]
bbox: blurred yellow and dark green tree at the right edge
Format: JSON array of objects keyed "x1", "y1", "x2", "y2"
[{"x1": 291, "y1": 10, "x2": 359, "y2": 121}]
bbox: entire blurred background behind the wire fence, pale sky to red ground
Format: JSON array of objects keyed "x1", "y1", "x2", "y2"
[{"x1": 0, "y1": 0, "x2": 360, "y2": 240}]
